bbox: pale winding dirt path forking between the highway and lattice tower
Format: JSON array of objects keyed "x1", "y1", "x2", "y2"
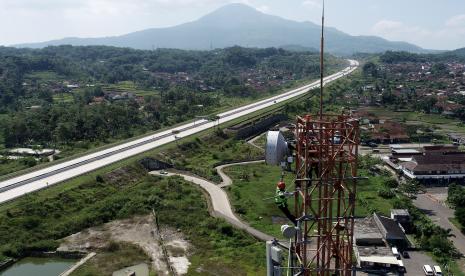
[{"x1": 150, "y1": 160, "x2": 274, "y2": 241}]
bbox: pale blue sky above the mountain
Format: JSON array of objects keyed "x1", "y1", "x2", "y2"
[{"x1": 0, "y1": 0, "x2": 465, "y2": 49}]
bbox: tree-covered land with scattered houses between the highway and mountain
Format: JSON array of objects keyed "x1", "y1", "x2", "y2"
[{"x1": 0, "y1": 46, "x2": 345, "y2": 174}]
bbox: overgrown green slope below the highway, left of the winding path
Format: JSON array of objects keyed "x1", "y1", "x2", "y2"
[{"x1": 0, "y1": 162, "x2": 264, "y2": 275}]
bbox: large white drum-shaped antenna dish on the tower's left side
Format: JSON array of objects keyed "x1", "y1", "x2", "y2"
[{"x1": 265, "y1": 131, "x2": 289, "y2": 166}]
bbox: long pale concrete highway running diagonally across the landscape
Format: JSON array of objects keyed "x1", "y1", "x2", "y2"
[{"x1": 0, "y1": 60, "x2": 359, "y2": 204}]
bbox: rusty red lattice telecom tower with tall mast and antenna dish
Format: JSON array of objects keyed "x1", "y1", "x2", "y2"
[{"x1": 266, "y1": 1, "x2": 360, "y2": 276}]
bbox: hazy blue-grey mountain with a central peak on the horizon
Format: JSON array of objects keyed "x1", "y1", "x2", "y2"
[{"x1": 15, "y1": 4, "x2": 426, "y2": 54}]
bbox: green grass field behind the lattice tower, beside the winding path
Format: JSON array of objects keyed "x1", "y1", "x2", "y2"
[{"x1": 225, "y1": 164, "x2": 393, "y2": 235}]
